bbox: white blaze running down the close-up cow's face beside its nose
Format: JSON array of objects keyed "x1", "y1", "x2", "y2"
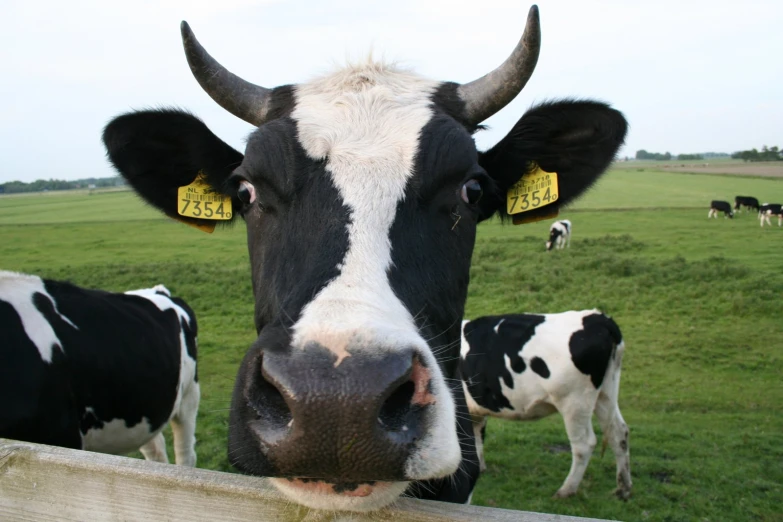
[{"x1": 292, "y1": 63, "x2": 461, "y2": 488}]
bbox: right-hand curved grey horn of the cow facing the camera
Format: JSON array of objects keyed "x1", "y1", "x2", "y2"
[{"x1": 458, "y1": 5, "x2": 541, "y2": 124}]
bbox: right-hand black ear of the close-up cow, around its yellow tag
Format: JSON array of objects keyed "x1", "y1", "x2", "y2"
[{"x1": 479, "y1": 100, "x2": 628, "y2": 220}]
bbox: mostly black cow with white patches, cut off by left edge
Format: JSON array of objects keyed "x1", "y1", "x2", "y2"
[{"x1": 0, "y1": 271, "x2": 200, "y2": 466}]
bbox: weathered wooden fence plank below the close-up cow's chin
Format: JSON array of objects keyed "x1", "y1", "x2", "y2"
[{"x1": 0, "y1": 439, "x2": 612, "y2": 522}]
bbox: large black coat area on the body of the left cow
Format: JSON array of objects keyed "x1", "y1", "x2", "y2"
[{"x1": 0, "y1": 280, "x2": 198, "y2": 449}]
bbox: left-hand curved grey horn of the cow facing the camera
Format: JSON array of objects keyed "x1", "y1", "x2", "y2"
[{"x1": 180, "y1": 21, "x2": 271, "y2": 126}]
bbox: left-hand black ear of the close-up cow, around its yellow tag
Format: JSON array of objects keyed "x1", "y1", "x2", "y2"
[{"x1": 103, "y1": 109, "x2": 243, "y2": 228}]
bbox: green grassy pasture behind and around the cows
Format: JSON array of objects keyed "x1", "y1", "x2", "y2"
[{"x1": 0, "y1": 168, "x2": 783, "y2": 521}]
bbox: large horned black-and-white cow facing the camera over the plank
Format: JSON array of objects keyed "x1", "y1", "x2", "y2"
[{"x1": 103, "y1": 6, "x2": 627, "y2": 511}]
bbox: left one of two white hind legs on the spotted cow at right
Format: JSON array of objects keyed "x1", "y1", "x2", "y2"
[{"x1": 555, "y1": 402, "x2": 596, "y2": 498}]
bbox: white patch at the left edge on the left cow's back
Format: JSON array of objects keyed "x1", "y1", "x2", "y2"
[{"x1": 0, "y1": 271, "x2": 79, "y2": 363}]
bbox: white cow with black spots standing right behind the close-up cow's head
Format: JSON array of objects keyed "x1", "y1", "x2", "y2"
[{"x1": 460, "y1": 310, "x2": 631, "y2": 499}]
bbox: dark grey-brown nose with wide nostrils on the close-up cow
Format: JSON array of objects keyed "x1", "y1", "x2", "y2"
[{"x1": 249, "y1": 343, "x2": 434, "y2": 483}]
